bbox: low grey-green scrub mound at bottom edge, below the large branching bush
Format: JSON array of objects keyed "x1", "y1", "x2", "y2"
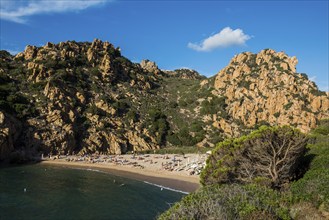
[{"x1": 158, "y1": 184, "x2": 290, "y2": 220}]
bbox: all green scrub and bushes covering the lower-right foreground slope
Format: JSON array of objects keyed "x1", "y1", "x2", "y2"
[{"x1": 158, "y1": 120, "x2": 329, "y2": 220}]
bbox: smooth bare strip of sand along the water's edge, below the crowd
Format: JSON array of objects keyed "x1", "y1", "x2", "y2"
[{"x1": 39, "y1": 155, "x2": 200, "y2": 193}]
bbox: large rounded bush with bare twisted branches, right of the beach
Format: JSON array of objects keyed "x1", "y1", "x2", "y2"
[{"x1": 201, "y1": 126, "x2": 308, "y2": 187}]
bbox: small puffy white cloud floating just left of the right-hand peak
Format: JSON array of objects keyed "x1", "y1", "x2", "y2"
[{"x1": 187, "y1": 27, "x2": 251, "y2": 51}]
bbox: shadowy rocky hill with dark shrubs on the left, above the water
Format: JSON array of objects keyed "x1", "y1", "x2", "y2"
[{"x1": 0, "y1": 40, "x2": 159, "y2": 158}]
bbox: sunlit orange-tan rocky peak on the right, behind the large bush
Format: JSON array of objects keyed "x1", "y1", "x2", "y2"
[{"x1": 214, "y1": 49, "x2": 329, "y2": 132}]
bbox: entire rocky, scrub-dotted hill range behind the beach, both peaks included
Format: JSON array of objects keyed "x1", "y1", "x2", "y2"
[{"x1": 0, "y1": 40, "x2": 329, "y2": 160}]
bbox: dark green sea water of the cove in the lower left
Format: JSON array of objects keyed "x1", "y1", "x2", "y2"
[{"x1": 0, "y1": 164, "x2": 184, "y2": 220}]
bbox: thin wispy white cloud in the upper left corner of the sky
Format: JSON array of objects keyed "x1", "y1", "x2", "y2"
[{"x1": 0, "y1": 0, "x2": 110, "y2": 23}]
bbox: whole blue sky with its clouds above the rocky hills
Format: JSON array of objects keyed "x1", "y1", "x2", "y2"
[{"x1": 0, "y1": 0, "x2": 329, "y2": 91}]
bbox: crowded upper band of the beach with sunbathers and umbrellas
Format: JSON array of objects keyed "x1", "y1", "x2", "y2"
[{"x1": 42, "y1": 153, "x2": 207, "y2": 175}]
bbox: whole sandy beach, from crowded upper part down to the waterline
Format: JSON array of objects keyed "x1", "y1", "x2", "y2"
[{"x1": 41, "y1": 154, "x2": 207, "y2": 192}]
